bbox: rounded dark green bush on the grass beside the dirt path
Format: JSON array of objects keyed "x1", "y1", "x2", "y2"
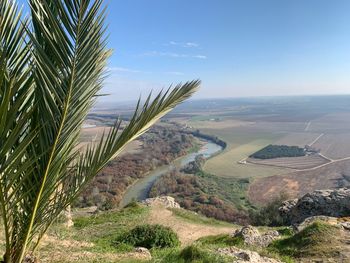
[{"x1": 116, "y1": 224, "x2": 180, "y2": 249}]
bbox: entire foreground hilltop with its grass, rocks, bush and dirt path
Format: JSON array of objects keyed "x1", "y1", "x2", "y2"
[{"x1": 0, "y1": 189, "x2": 350, "y2": 263}]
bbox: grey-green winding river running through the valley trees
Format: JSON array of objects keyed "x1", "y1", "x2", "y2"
[{"x1": 120, "y1": 139, "x2": 223, "y2": 207}]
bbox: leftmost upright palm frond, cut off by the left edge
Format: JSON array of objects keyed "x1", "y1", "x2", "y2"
[{"x1": 0, "y1": 1, "x2": 35, "y2": 258}]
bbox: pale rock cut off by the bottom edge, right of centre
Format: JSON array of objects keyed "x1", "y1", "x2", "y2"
[{"x1": 217, "y1": 247, "x2": 281, "y2": 263}]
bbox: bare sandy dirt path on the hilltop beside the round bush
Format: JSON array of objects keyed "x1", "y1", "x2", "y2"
[{"x1": 149, "y1": 205, "x2": 234, "y2": 246}]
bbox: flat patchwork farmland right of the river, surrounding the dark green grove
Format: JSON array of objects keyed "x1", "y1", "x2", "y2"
[{"x1": 169, "y1": 96, "x2": 350, "y2": 204}]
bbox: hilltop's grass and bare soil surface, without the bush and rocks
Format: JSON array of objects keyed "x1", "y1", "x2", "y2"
[{"x1": 0, "y1": 203, "x2": 343, "y2": 263}]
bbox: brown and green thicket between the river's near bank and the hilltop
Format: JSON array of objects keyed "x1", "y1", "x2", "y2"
[{"x1": 150, "y1": 171, "x2": 249, "y2": 223}]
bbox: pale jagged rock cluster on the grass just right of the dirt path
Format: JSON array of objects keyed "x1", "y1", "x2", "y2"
[{"x1": 232, "y1": 226, "x2": 279, "y2": 247}]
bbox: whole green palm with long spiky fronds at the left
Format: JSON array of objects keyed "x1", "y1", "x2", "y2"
[{"x1": 0, "y1": 0, "x2": 200, "y2": 263}]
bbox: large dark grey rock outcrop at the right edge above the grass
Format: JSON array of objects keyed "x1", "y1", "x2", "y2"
[{"x1": 279, "y1": 188, "x2": 350, "y2": 224}]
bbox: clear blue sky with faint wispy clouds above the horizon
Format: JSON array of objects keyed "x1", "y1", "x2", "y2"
[{"x1": 17, "y1": 0, "x2": 350, "y2": 101}]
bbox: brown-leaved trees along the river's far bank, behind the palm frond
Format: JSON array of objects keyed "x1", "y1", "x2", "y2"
[{"x1": 75, "y1": 126, "x2": 198, "y2": 210}]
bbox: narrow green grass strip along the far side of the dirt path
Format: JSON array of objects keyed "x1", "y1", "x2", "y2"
[{"x1": 169, "y1": 208, "x2": 234, "y2": 227}]
